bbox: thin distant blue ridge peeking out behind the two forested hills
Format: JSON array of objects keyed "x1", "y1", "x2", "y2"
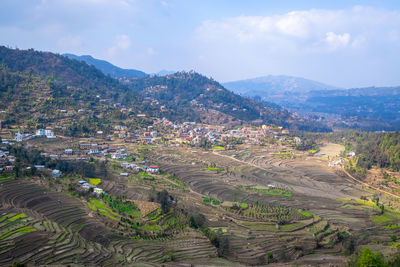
[{"x1": 63, "y1": 54, "x2": 147, "y2": 78}]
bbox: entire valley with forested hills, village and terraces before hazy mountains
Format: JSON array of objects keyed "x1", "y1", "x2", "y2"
[{"x1": 0, "y1": 47, "x2": 400, "y2": 266}]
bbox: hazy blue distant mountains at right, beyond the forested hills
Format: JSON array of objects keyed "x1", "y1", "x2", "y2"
[{"x1": 224, "y1": 75, "x2": 400, "y2": 130}]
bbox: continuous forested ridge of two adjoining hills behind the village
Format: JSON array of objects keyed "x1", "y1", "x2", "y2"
[{"x1": 0, "y1": 47, "x2": 329, "y2": 134}]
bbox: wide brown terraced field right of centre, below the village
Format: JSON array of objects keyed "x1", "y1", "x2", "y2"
[{"x1": 153, "y1": 148, "x2": 398, "y2": 264}]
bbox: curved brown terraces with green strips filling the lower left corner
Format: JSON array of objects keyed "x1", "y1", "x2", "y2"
[{"x1": 0, "y1": 180, "x2": 216, "y2": 266}]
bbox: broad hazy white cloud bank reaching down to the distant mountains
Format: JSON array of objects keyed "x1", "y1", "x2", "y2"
[{"x1": 193, "y1": 6, "x2": 400, "y2": 87}]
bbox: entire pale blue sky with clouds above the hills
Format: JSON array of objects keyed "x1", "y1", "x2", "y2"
[{"x1": 0, "y1": 0, "x2": 400, "y2": 88}]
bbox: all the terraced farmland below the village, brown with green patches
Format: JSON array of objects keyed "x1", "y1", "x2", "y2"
[{"x1": 0, "y1": 137, "x2": 400, "y2": 265}]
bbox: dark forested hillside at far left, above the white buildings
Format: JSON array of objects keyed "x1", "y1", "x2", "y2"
[{"x1": 0, "y1": 47, "x2": 148, "y2": 132}]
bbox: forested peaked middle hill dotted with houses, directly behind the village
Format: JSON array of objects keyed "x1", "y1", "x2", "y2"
[{"x1": 128, "y1": 71, "x2": 329, "y2": 131}]
